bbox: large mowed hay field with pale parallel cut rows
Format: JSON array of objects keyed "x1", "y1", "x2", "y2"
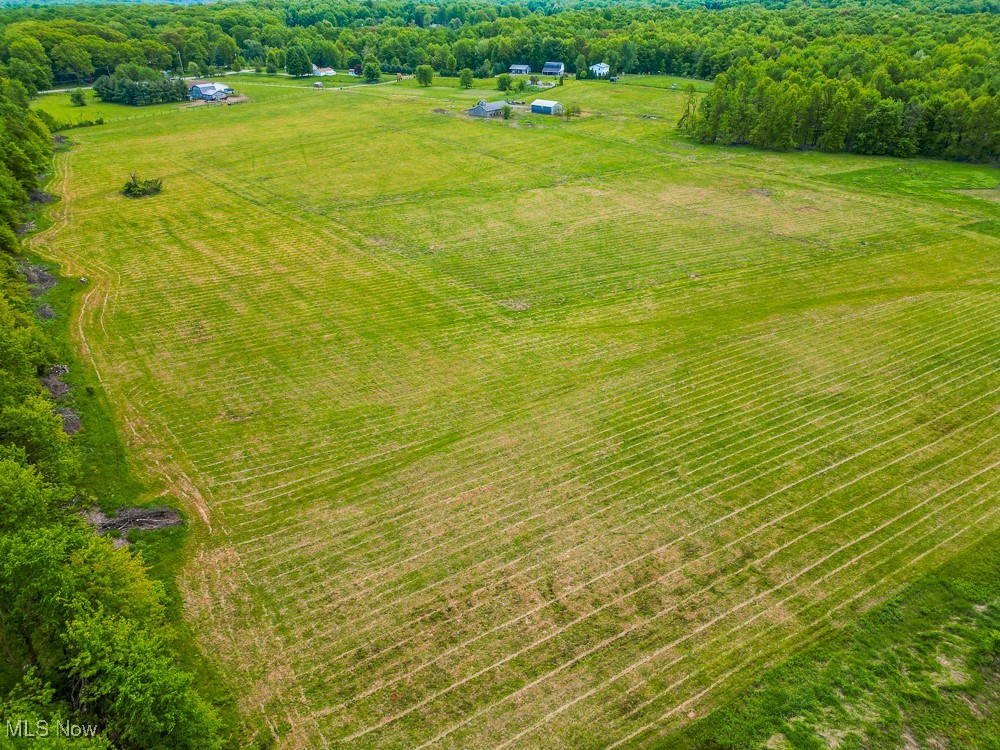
[{"x1": 34, "y1": 82, "x2": 1000, "y2": 748}]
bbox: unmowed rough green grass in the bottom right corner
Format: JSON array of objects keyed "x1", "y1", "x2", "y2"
[{"x1": 658, "y1": 535, "x2": 1000, "y2": 750}]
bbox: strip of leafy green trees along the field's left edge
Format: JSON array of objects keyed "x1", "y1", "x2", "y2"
[{"x1": 0, "y1": 78, "x2": 219, "y2": 748}]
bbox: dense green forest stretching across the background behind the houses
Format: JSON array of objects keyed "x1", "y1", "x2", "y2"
[{"x1": 0, "y1": 0, "x2": 1000, "y2": 162}]
